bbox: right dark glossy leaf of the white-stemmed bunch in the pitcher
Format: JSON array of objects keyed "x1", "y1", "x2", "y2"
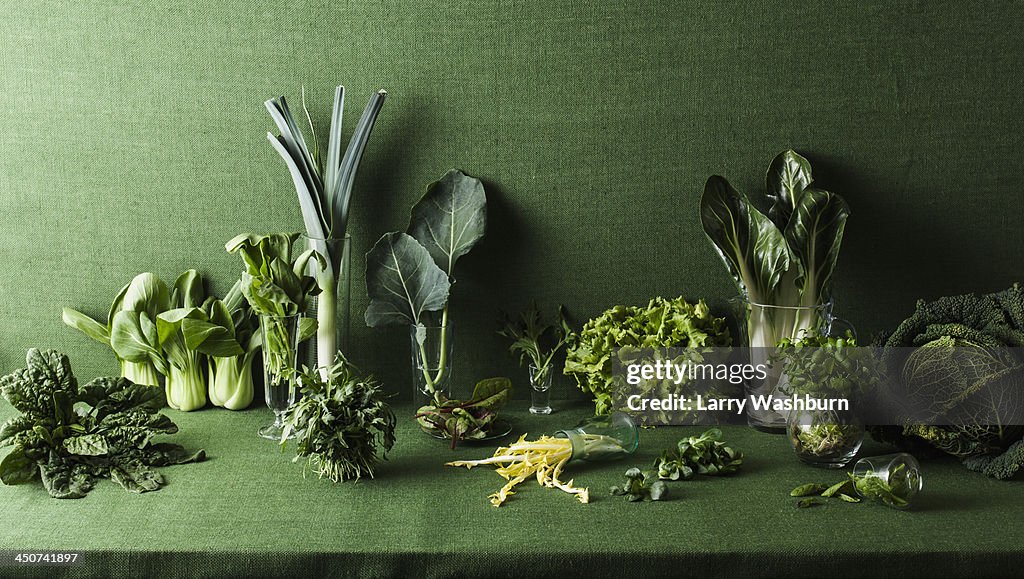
[{"x1": 785, "y1": 189, "x2": 850, "y2": 305}]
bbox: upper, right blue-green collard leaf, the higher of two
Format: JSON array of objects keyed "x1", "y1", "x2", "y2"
[{"x1": 409, "y1": 169, "x2": 487, "y2": 278}]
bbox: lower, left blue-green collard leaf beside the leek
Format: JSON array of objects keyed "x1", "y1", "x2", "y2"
[{"x1": 365, "y1": 233, "x2": 451, "y2": 328}]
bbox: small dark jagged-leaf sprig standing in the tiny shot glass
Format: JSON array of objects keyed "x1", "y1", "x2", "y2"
[{"x1": 498, "y1": 302, "x2": 572, "y2": 384}]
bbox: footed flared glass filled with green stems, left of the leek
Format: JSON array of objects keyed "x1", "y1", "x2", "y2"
[{"x1": 259, "y1": 316, "x2": 301, "y2": 441}]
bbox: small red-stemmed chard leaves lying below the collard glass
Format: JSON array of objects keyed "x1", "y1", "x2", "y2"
[{"x1": 416, "y1": 378, "x2": 512, "y2": 448}]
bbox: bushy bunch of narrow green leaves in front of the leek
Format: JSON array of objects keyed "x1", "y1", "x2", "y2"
[{"x1": 282, "y1": 351, "x2": 395, "y2": 483}]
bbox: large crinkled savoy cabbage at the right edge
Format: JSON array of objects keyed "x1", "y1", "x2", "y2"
[{"x1": 872, "y1": 284, "x2": 1024, "y2": 479}]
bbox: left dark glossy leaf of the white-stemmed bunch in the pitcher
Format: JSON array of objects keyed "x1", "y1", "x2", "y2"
[{"x1": 700, "y1": 175, "x2": 792, "y2": 303}]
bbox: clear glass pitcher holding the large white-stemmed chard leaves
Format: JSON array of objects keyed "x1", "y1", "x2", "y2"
[{"x1": 733, "y1": 298, "x2": 853, "y2": 432}]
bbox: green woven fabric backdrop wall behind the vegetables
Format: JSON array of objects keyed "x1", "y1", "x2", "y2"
[{"x1": 0, "y1": 0, "x2": 1024, "y2": 394}]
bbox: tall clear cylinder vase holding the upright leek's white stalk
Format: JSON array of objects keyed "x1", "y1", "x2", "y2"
[{"x1": 293, "y1": 234, "x2": 352, "y2": 368}]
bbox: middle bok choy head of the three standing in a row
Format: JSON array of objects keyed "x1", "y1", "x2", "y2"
[{"x1": 181, "y1": 281, "x2": 262, "y2": 410}]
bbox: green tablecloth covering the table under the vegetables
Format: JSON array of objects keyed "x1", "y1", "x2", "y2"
[{"x1": 0, "y1": 403, "x2": 1024, "y2": 577}]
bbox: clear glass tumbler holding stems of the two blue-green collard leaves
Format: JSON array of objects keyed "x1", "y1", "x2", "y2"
[{"x1": 409, "y1": 320, "x2": 455, "y2": 404}]
